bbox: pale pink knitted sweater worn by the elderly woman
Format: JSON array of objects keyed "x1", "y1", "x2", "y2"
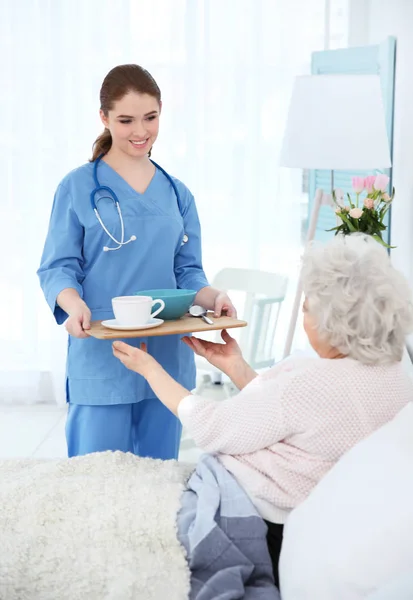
[{"x1": 179, "y1": 357, "x2": 413, "y2": 523}]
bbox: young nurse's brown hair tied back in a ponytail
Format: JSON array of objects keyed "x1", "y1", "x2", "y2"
[{"x1": 90, "y1": 65, "x2": 161, "y2": 162}]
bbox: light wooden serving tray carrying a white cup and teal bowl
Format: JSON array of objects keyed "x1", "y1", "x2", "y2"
[{"x1": 85, "y1": 313, "x2": 247, "y2": 340}]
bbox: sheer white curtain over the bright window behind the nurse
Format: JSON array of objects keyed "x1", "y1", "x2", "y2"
[{"x1": 0, "y1": 0, "x2": 347, "y2": 403}]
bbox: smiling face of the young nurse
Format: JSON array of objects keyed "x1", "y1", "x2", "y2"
[{"x1": 100, "y1": 92, "x2": 161, "y2": 158}]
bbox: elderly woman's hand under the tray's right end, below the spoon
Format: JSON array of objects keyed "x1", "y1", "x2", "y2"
[{"x1": 182, "y1": 329, "x2": 244, "y2": 373}]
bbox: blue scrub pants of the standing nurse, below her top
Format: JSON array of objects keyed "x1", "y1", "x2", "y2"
[{"x1": 66, "y1": 398, "x2": 182, "y2": 460}]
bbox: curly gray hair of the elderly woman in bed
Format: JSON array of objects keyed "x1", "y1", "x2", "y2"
[{"x1": 302, "y1": 234, "x2": 413, "y2": 364}]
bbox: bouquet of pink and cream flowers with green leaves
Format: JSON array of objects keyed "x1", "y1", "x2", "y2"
[{"x1": 328, "y1": 175, "x2": 394, "y2": 248}]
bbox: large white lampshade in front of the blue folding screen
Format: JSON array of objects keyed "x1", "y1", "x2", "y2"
[{"x1": 280, "y1": 75, "x2": 391, "y2": 170}]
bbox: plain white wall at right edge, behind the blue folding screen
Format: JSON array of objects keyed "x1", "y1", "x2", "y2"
[{"x1": 349, "y1": 0, "x2": 413, "y2": 284}]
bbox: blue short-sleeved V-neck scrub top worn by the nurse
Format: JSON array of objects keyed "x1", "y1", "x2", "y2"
[{"x1": 38, "y1": 161, "x2": 209, "y2": 405}]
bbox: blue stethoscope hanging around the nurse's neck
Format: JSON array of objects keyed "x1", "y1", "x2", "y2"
[{"x1": 90, "y1": 154, "x2": 188, "y2": 252}]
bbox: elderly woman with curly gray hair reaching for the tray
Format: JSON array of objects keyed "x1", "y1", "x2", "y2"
[{"x1": 113, "y1": 234, "x2": 413, "y2": 583}]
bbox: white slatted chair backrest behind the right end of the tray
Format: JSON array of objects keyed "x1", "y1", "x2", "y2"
[{"x1": 212, "y1": 268, "x2": 288, "y2": 369}]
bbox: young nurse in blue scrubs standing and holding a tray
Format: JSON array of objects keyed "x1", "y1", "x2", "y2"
[{"x1": 38, "y1": 64, "x2": 236, "y2": 459}]
